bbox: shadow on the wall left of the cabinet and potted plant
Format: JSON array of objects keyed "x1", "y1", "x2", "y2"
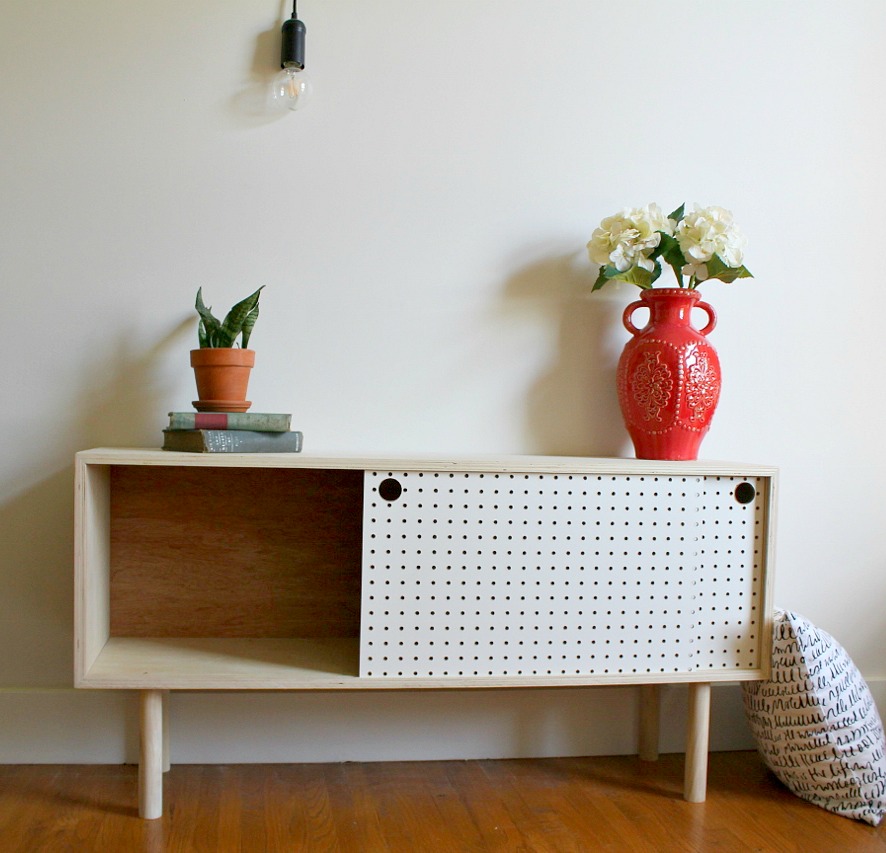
[{"x1": 0, "y1": 320, "x2": 194, "y2": 687}]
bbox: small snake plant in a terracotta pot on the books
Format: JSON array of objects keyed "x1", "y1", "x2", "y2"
[{"x1": 191, "y1": 285, "x2": 264, "y2": 412}]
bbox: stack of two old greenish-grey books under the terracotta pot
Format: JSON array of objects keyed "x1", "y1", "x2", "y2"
[{"x1": 163, "y1": 412, "x2": 304, "y2": 453}]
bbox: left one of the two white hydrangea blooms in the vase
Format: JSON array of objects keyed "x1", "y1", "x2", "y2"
[{"x1": 588, "y1": 203, "x2": 674, "y2": 272}]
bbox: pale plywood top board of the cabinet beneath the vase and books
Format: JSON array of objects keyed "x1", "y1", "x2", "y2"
[{"x1": 77, "y1": 447, "x2": 777, "y2": 476}]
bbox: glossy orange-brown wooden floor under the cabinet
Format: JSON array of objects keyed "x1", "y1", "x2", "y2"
[{"x1": 0, "y1": 752, "x2": 886, "y2": 853}]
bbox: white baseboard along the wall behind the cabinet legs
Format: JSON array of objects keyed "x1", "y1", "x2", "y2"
[{"x1": 0, "y1": 678, "x2": 886, "y2": 764}]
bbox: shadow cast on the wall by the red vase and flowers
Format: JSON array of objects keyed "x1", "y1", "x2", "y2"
[{"x1": 505, "y1": 254, "x2": 635, "y2": 456}]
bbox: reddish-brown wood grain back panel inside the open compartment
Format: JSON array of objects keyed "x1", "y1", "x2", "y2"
[{"x1": 110, "y1": 465, "x2": 363, "y2": 638}]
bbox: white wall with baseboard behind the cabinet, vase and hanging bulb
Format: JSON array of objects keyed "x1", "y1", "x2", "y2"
[{"x1": 0, "y1": 0, "x2": 886, "y2": 761}]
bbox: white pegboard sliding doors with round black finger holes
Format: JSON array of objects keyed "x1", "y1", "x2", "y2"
[{"x1": 360, "y1": 471, "x2": 762, "y2": 678}]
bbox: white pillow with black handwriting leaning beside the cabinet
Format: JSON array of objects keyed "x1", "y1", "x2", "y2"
[{"x1": 742, "y1": 611, "x2": 886, "y2": 826}]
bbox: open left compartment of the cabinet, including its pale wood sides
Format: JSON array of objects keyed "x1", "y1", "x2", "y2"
[{"x1": 77, "y1": 454, "x2": 363, "y2": 689}]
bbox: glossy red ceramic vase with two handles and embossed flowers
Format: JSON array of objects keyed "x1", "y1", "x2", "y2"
[{"x1": 618, "y1": 288, "x2": 721, "y2": 460}]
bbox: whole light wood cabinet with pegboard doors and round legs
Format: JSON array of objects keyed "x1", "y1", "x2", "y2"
[{"x1": 75, "y1": 449, "x2": 776, "y2": 817}]
